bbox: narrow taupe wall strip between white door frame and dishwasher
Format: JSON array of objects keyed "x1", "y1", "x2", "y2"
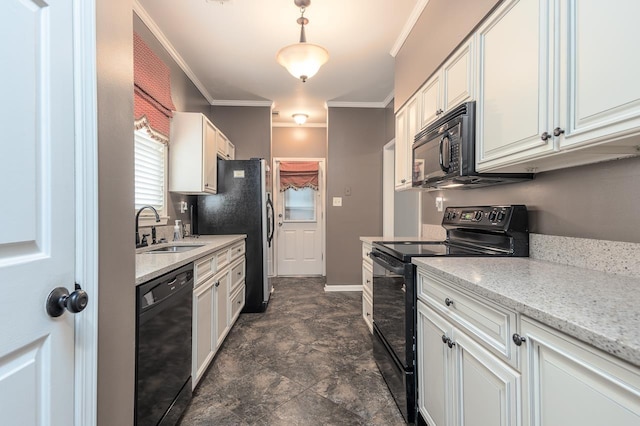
[{"x1": 95, "y1": 0, "x2": 136, "y2": 426}]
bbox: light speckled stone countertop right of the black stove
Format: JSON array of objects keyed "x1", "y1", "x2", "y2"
[{"x1": 413, "y1": 257, "x2": 640, "y2": 366}]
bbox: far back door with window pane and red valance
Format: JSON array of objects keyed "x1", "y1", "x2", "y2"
[{"x1": 275, "y1": 159, "x2": 324, "y2": 276}]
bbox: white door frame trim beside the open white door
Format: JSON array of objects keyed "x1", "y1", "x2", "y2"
[{"x1": 73, "y1": 0, "x2": 99, "y2": 426}]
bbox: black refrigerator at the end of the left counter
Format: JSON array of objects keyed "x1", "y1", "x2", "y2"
[{"x1": 194, "y1": 159, "x2": 274, "y2": 312}]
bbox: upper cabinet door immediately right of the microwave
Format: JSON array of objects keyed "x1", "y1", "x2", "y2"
[{"x1": 476, "y1": 0, "x2": 554, "y2": 171}]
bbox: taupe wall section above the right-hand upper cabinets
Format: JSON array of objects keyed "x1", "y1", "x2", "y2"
[{"x1": 394, "y1": 0, "x2": 501, "y2": 111}]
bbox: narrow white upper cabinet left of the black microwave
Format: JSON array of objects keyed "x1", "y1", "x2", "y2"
[{"x1": 395, "y1": 96, "x2": 420, "y2": 191}]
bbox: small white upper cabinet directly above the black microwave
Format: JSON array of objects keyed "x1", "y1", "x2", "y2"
[{"x1": 419, "y1": 37, "x2": 475, "y2": 129}]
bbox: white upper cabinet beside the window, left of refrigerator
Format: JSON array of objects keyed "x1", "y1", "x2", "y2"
[{"x1": 169, "y1": 112, "x2": 217, "y2": 194}]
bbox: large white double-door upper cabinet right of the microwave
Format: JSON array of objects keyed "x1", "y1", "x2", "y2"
[{"x1": 476, "y1": 0, "x2": 640, "y2": 172}]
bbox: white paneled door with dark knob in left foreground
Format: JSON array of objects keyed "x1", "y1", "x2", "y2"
[{"x1": 0, "y1": 0, "x2": 76, "y2": 426}]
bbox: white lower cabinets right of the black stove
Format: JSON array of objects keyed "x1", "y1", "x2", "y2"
[{"x1": 416, "y1": 268, "x2": 640, "y2": 426}]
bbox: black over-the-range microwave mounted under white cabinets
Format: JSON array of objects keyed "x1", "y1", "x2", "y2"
[{"x1": 412, "y1": 102, "x2": 533, "y2": 190}]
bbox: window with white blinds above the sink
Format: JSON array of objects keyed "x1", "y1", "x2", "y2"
[{"x1": 135, "y1": 128, "x2": 167, "y2": 217}]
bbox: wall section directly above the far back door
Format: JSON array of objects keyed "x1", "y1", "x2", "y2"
[{"x1": 271, "y1": 127, "x2": 327, "y2": 158}]
